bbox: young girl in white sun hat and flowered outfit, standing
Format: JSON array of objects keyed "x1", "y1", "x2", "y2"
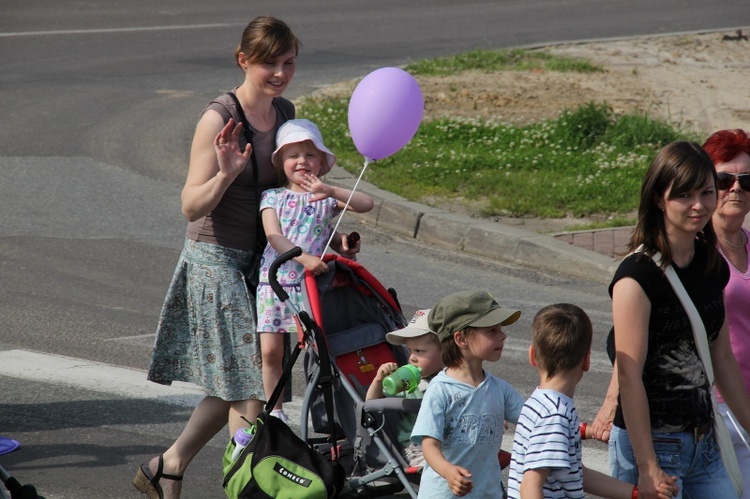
[{"x1": 257, "y1": 119, "x2": 373, "y2": 421}]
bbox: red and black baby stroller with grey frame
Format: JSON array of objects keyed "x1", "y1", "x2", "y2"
[{"x1": 269, "y1": 248, "x2": 420, "y2": 498}]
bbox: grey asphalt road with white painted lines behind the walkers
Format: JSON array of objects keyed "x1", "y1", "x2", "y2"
[{"x1": 0, "y1": 0, "x2": 750, "y2": 499}]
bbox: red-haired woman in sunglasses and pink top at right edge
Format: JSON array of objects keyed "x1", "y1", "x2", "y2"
[{"x1": 703, "y1": 130, "x2": 750, "y2": 499}]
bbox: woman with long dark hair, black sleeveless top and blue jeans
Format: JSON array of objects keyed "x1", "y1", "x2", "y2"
[{"x1": 609, "y1": 142, "x2": 750, "y2": 499}]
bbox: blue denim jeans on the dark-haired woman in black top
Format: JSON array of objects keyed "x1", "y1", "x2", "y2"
[{"x1": 609, "y1": 426, "x2": 737, "y2": 499}]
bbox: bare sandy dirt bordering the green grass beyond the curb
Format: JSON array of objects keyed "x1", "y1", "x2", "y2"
[{"x1": 308, "y1": 29, "x2": 750, "y2": 232}]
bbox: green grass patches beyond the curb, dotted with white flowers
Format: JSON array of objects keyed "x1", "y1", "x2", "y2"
[{"x1": 298, "y1": 51, "x2": 695, "y2": 225}]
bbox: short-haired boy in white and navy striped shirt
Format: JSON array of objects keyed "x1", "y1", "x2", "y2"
[{"x1": 508, "y1": 303, "x2": 676, "y2": 499}]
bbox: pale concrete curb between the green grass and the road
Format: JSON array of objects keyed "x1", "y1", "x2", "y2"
[{"x1": 326, "y1": 166, "x2": 617, "y2": 284}]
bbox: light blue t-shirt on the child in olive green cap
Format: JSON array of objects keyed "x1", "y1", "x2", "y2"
[{"x1": 411, "y1": 371, "x2": 523, "y2": 499}]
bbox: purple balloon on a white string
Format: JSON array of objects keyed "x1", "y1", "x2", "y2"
[{"x1": 349, "y1": 68, "x2": 424, "y2": 160}]
